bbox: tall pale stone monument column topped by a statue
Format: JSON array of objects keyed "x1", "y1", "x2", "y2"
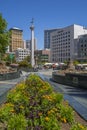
[{"x1": 30, "y1": 19, "x2": 35, "y2": 67}]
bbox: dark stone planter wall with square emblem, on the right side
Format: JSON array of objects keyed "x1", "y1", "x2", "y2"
[{"x1": 52, "y1": 72, "x2": 87, "y2": 88}]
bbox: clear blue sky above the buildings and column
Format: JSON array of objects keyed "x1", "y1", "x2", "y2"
[{"x1": 0, "y1": 0, "x2": 87, "y2": 49}]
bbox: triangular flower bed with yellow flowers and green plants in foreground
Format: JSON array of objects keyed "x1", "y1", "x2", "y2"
[{"x1": 0, "y1": 75, "x2": 87, "y2": 130}]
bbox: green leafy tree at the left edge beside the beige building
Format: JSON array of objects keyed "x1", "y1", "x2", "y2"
[{"x1": 0, "y1": 14, "x2": 10, "y2": 58}]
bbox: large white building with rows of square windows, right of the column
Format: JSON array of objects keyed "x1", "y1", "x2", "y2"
[{"x1": 50, "y1": 24, "x2": 87, "y2": 62}]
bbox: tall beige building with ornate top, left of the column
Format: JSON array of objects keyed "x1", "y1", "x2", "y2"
[{"x1": 9, "y1": 27, "x2": 24, "y2": 52}]
